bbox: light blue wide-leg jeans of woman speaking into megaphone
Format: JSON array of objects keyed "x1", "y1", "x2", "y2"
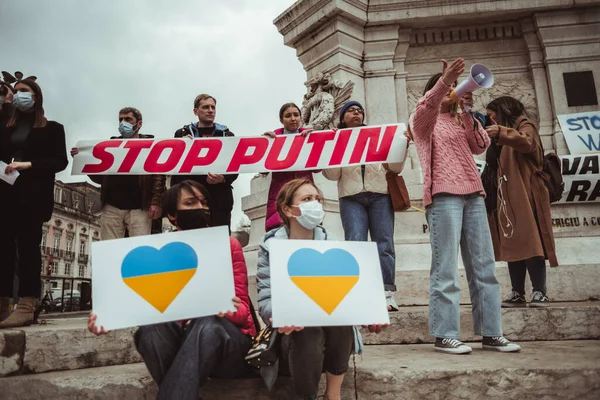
[{"x1": 427, "y1": 194, "x2": 502, "y2": 339}]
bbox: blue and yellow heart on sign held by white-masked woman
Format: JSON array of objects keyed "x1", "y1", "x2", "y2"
[{"x1": 288, "y1": 249, "x2": 360, "y2": 315}]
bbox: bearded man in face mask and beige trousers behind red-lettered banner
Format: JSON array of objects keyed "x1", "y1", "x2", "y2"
[{"x1": 71, "y1": 107, "x2": 166, "y2": 240}]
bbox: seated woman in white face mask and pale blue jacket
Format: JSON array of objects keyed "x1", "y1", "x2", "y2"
[{"x1": 256, "y1": 179, "x2": 382, "y2": 400}]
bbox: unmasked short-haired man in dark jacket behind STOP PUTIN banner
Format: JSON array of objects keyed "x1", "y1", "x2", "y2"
[{"x1": 171, "y1": 94, "x2": 238, "y2": 227}]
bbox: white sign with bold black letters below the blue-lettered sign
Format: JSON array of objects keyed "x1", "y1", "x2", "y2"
[{"x1": 558, "y1": 154, "x2": 600, "y2": 203}]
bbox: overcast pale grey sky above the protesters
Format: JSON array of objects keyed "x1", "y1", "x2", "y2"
[{"x1": 0, "y1": 0, "x2": 306, "y2": 226}]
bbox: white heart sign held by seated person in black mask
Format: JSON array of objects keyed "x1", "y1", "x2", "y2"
[{"x1": 91, "y1": 226, "x2": 235, "y2": 330}]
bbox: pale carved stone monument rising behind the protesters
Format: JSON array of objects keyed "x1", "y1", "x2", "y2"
[{"x1": 243, "y1": 0, "x2": 600, "y2": 305}]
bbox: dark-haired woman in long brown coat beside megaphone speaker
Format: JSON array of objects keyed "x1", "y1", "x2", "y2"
[{"x1": 486, "y1": 96, "x2": 558, "y2": 307}]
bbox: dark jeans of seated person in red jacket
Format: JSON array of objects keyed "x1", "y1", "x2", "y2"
[{"x1": 135, "y1": 316, "x2": 251, "y2": 400}]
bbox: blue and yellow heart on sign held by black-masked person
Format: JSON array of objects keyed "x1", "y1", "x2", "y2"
[{"x1": 121, "y1": 242, "x2": 198, "y2": 313}]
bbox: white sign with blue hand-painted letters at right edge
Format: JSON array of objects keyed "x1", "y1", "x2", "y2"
[{"x1": 558, "y1": 111, "x2": 600, "y2": 155}]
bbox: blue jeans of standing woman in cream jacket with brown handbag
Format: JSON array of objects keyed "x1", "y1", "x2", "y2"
[{"x1": 340, "y1": 192, "x2": 396, "y2": 291}]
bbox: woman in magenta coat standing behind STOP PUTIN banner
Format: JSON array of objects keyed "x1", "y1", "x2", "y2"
[{"x1": 264, "y1": 103, "x2": 320, "y2": 232}]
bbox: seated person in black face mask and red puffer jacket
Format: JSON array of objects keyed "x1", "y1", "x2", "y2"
[{"x1": 88, "y1": 180, "x2": 256, "y2": 400}]
